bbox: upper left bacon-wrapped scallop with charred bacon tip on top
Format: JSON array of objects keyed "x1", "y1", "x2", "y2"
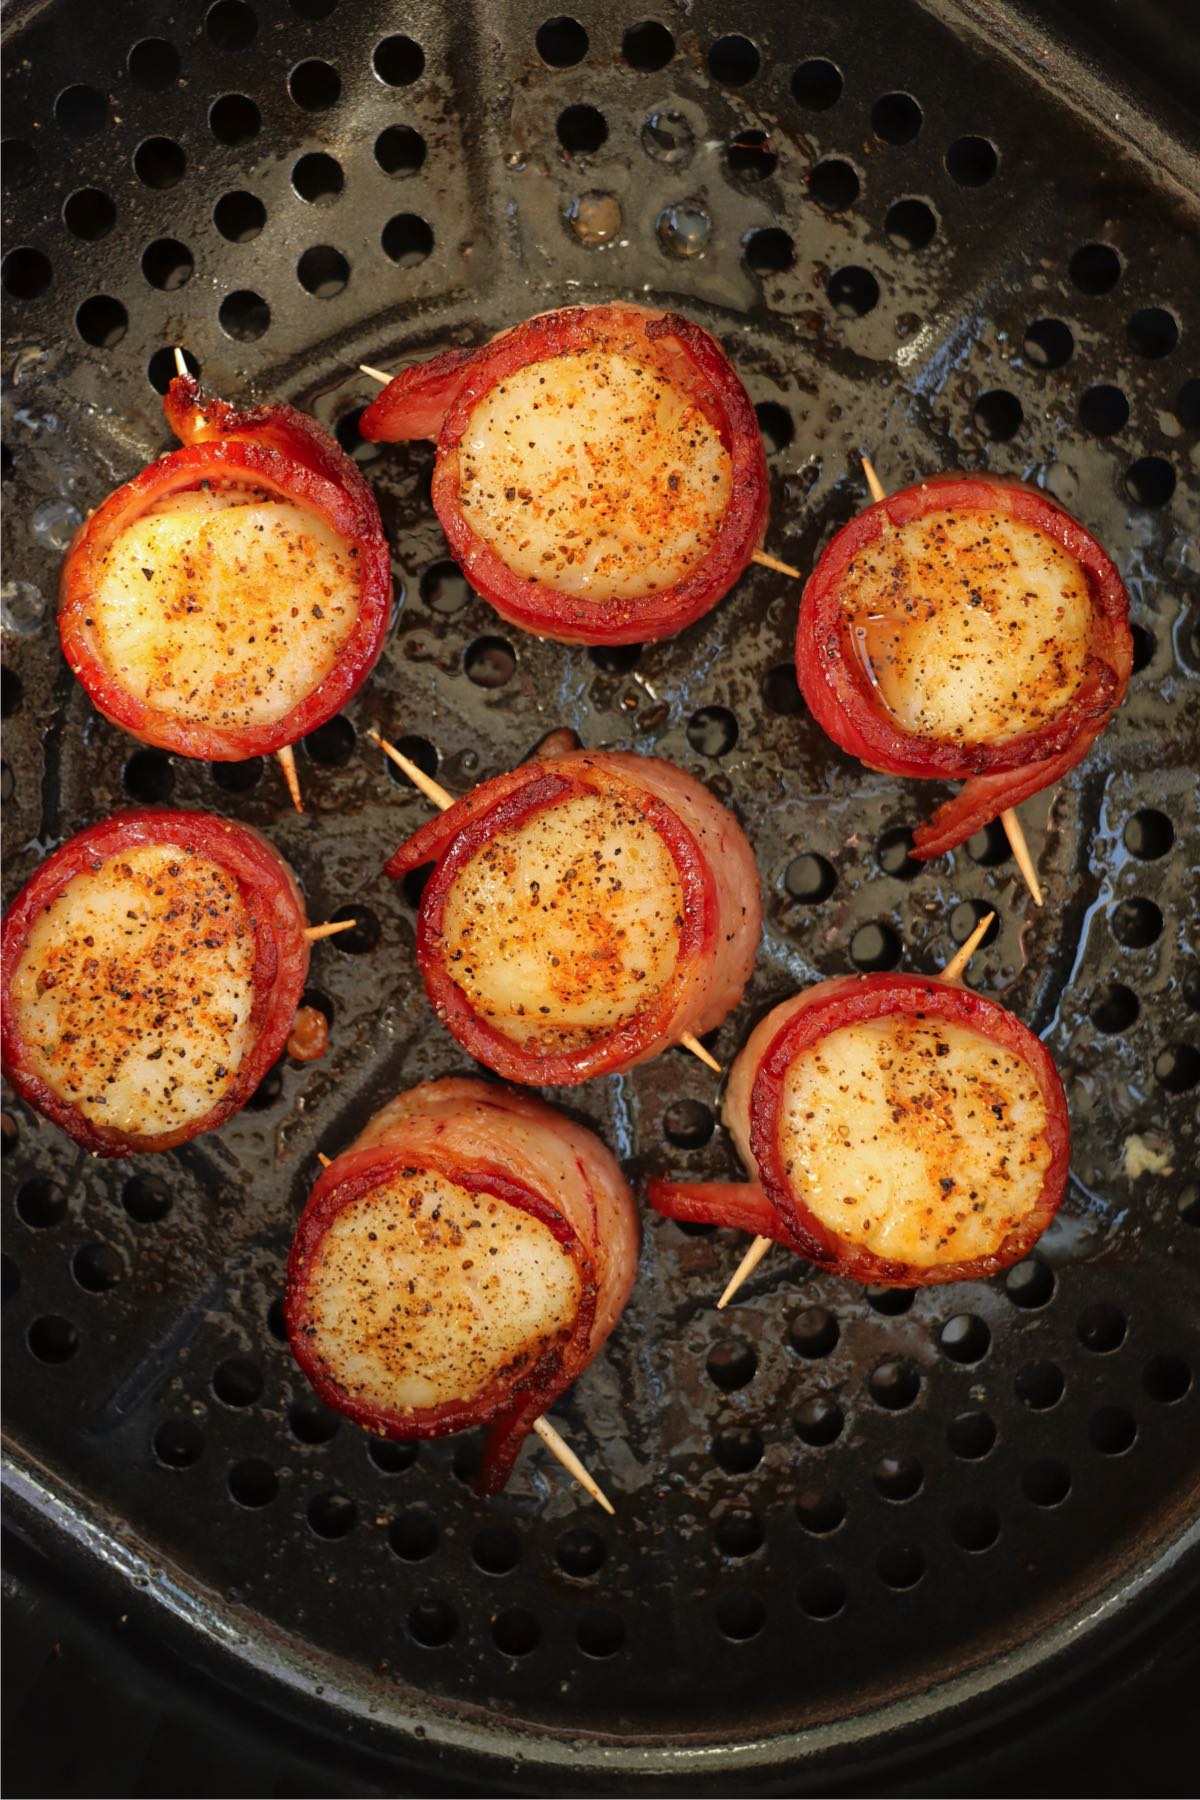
[{"x1": 59, "y1": 376, "x2": 392, "y2": 777}]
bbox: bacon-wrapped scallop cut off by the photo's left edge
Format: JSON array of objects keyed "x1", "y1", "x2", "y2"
[{"x1": 0, "y1": 808, "x2": 309, "y2": 1156}]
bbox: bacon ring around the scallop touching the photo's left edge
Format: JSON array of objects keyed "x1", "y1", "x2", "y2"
[{"x1": 0, "y1": 806, "x2": 309, "y2": 1157}]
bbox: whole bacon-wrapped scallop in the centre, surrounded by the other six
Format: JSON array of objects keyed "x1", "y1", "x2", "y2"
[{"x1": 387, "y1": 751, "x2": 763, "y2": 1087}]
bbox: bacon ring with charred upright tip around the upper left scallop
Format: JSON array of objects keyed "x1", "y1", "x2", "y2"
[{"x1": 58, "y1": 374, "x2": 392, "y2": 761}]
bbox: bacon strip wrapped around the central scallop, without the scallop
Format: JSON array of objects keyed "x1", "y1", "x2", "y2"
[{"x1": 385, "y1": 751, "x2": 763, "y2": 1087}]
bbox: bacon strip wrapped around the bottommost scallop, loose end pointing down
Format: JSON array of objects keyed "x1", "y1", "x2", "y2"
[{"x1": 286, "y1": 1078, "x2": 639, "y2": 1494}]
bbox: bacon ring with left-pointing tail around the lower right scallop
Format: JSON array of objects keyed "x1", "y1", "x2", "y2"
[{"x1": 649, "y1": 974, "x2": 1070, "y2": 1287}]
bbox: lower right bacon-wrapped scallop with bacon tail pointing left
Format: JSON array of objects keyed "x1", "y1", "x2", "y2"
[{"x1": 649, "y1": 974, "x2": 1070, "y2": 1287}]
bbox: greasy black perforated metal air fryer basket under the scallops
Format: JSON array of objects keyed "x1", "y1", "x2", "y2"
[{"x1": 4, "y1": 0, "x2": 1200, "y2": 1791}]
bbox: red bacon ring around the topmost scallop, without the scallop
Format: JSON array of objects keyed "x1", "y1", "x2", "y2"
[{"x1": 360, "y1": 306, "x2": 770, "y2": 644}]
